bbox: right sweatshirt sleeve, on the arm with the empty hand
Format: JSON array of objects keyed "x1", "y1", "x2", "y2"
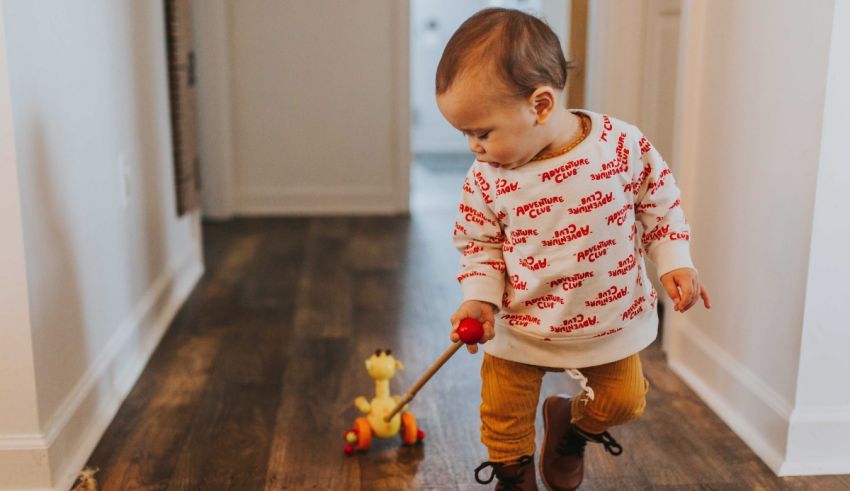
[{"x1": 632, "y1": 132, "x2": 696, "y2": 277}]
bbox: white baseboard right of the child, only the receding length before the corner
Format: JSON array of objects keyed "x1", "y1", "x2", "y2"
[{"x1": 664, "y1": 319, "x2": 791, "y2": 474}]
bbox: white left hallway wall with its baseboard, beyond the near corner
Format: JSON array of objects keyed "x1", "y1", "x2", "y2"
[{"x1": 0, "y1": 0, "x2": 202, "y2": 489}]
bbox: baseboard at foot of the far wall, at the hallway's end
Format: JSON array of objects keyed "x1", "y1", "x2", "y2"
[{"x1": 236, "y1": 186, "x2": 408, "y2": 216}]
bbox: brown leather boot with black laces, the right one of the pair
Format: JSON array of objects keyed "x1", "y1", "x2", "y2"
[{"x1": 540, "y1": 394, "x2": 623, "y2": 491}]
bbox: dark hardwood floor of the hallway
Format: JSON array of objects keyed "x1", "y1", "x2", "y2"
[{"x1": 81, "y1": 161, "x2": 850, "y2": 491}]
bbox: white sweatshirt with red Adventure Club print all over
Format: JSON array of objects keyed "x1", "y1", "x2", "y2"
[{"x1": 453, "y1": 111, "x2": 693, "y2": 368}]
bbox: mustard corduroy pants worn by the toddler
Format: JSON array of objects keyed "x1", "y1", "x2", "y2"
[{"x1": 481, "y1": 353, "x2": 649, "y2": 462}]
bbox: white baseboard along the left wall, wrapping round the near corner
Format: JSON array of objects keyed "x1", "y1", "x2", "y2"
[{"x1": 0, "y1": 242, "x2": 204, "y2": 491}]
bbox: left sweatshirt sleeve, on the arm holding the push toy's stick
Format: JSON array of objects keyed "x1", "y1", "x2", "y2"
[{"x1": 452, "y1": 165, "x2": 505, "y2": 308}]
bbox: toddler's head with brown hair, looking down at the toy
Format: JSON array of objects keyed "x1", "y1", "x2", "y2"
[{"x1": 437, "y1": 8, "x2": 567, "y2": 168}]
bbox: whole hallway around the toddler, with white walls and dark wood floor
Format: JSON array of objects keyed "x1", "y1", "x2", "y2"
[{"x1": 0, "y1": 0, "x2": 850, "y2": 491}]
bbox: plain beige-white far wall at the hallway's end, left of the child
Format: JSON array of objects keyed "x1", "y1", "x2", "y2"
[{"x1": 204, "y1": 0, "x2": 410, "y2": 214}]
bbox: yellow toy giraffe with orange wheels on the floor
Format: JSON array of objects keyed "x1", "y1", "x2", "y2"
[{"x1": 343, "y1": 350, "x2": 425, "y2": 455}]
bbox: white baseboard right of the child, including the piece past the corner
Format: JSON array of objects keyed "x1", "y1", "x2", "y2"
[{"x1": 665, "y1": 318, "x2": 850, "y2": 476}]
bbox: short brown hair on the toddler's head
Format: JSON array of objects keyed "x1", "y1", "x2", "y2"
[{"x1": 437, "y1": 8, "x2": 569, "y2": 97}]
